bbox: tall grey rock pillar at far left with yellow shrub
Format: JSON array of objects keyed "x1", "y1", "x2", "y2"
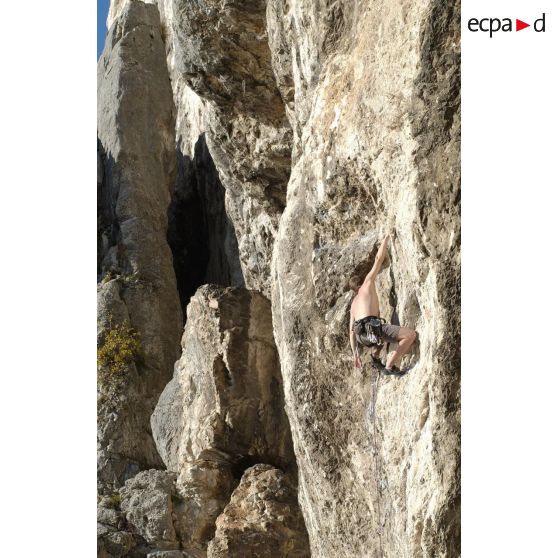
[{"x1": 97, "y1": 2, "x2": 182, "y2": 493}]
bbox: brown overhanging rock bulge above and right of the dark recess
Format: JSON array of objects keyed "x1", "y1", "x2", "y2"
[{"x1": 166, "y1": 0, "x2": 291, "y2": 296}]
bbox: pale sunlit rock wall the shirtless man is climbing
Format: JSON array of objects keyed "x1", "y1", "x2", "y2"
[{"x1": 268, "y1": 1, "x2": 460, "y2": 557}]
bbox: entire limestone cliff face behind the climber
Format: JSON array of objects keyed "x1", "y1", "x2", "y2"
[{"x1": 98, "y1": 0, "x2": 460, "y2": 558}]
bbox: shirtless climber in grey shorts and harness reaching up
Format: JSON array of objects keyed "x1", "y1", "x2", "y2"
[{"x1": 349, "y1": 235, "x2": 417, "y2": 376}]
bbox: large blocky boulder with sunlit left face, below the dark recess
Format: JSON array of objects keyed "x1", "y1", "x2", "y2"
[{"x1": 151, "y1": 285, "x2": 296, "y2": 556}]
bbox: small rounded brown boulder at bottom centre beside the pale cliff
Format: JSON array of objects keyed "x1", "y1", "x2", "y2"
[{"x1": 207, "y1": 465, "x2": 310, "y2": 558}]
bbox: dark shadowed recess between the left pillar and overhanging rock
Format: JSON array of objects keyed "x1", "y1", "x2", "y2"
[{"x1": 167, "y1": 134, "x2": 244, "y2": 318}]
